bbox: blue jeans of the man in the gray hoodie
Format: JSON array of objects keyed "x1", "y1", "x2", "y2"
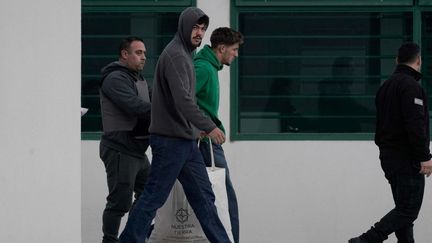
[{"x1": 120, "y1": 135, "x2": 231, "y2": 243}]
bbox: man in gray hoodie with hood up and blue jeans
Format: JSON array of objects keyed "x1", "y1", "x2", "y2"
[{"x1": 120, "y1": 7, "x2": 231, "y2": 243}]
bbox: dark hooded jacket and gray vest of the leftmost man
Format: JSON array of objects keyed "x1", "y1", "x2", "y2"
[{"x1": 100, "y1": 61, "x2": 151, "y2": 157}]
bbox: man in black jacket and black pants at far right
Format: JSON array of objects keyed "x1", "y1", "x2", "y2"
[{"x1": 349, "y1": 43, "x2": 432, "y2": 243}]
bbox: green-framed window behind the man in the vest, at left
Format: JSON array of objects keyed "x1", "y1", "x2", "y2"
[{"x1": 81, "y1": 0, "x2": 195, "y2": 139}]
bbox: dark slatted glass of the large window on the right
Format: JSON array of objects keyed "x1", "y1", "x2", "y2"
[{"x1": 237, "y1": 12, "x2": 412, "y2": 134}]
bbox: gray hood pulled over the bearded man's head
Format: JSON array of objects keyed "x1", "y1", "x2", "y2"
[{"x1": 176, "y1": 7, "x2": 209, "y2": 52}]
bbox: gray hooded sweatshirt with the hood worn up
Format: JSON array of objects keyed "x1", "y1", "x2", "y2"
[{"x1": 149, "y1": 7, "x2": 216, "y2": 140}]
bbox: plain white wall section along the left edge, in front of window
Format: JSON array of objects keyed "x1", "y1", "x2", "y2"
[{"x1": 0, "y1": 0, "x2": 81, "y2": 243}]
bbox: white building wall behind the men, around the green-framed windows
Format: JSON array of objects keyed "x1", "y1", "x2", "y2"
[{"x1": 82, "y1": 0, "x2": 432, "y2": 243}]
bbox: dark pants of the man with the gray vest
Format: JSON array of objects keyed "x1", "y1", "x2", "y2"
[{"x1": 100, "y1": 145, "x2": 150, "y2": 243}]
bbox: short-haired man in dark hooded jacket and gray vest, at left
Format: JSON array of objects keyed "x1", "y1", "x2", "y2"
[{"x1": 100, "y1": 37, "x2": 151, "y2": 243}]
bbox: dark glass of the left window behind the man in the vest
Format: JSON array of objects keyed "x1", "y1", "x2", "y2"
[{"x1": 81, "y1": 13, "x2": 178, "y2": 132}]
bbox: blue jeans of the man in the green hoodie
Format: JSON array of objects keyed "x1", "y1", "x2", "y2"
[{"x1": 200, "y1": 142, "x2": 240, "y2": 243}]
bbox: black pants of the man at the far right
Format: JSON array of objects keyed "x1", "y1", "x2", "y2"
[{"x1": 361, "y1": 158, "x2": 425, "y2": 243}]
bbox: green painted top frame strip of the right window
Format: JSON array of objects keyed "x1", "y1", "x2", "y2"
[{"x1": 235, "y1": 0, "x2": 414, "y2": 6}]
